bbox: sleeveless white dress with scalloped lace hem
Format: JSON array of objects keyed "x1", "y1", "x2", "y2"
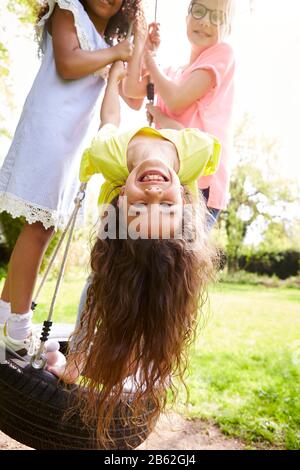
[{"x1": 0, "y1": 0, "x2": 108, "y2": 229}]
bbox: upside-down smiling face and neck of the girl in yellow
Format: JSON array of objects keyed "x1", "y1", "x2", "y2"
[{"x1": 119, "y1": 135, "x2": 184, "y2": 238}]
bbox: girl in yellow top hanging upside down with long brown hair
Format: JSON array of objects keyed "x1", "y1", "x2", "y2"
[{"x1": 48, "y1": 63, "x2": 220, "y2": 443}]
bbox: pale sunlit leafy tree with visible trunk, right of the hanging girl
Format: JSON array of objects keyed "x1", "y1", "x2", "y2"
[{"x1": 220, "y1": 115, "x2": 299, "y2": 271}]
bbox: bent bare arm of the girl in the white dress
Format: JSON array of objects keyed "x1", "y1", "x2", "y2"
[{"x1": 49, "y1": 6, "x2": 133, "y2": 80}]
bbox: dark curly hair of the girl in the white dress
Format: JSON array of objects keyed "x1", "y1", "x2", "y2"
[{"x1": 37, "y1": 0, "x2": 141, "y2": 46}]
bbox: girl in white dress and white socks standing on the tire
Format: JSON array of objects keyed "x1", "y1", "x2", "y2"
[{"x1": 0, "y1": 0, "x2": 140, "y2": 351}]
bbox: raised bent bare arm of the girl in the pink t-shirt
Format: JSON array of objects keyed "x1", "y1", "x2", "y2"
[{"x1": 144, "y1": 51, "x2": 215, "y2": 114}]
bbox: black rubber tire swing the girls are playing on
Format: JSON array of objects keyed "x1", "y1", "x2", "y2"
[{"x1": 0, "y1": 346, "x2": 155, "y2": 450}]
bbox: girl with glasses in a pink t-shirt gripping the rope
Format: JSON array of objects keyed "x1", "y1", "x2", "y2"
[{"x1": 123, "y1": 0, "x2": 235, "y2": 226}]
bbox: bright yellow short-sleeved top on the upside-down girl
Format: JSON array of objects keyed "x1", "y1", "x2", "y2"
[{"x1": 80, "y1": 124, "x2": 221, "y2": 204}]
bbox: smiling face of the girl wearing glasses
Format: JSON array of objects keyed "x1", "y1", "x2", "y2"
[{"x1": 186, "y1": 0, "x2": 229, "y2": 53}]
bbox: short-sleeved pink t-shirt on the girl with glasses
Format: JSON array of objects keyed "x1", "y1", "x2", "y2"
[{"x1": 157, "y1": 43, "x2": 235, "y2": 209}]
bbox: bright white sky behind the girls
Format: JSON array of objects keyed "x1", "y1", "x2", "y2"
[{"x1": 0, "y1": 0, "x2": 300, "y2": 184}]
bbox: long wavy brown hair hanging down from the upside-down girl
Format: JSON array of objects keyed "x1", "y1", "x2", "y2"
[{"x1": 67, "y1": 194, "x2": 217, "y2": 447}]
